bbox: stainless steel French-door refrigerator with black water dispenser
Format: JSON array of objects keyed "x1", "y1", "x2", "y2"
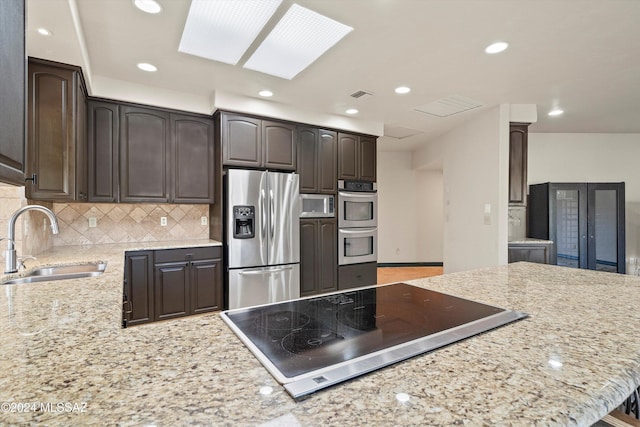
[{"x1": 226, "y1": 169, "x2": 300, "y2": 309}]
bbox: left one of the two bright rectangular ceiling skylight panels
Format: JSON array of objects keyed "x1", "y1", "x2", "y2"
[{"x1": 178, "y1": 0, "x2": 282, "y2": 65}]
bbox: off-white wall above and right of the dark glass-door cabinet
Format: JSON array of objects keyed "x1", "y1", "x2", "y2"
[{"x1": 528, "y1": 133, "x2": 640, "y2": 274}]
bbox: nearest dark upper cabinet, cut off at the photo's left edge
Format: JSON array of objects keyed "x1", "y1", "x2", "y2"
[{"x1": 0, "y1": 0, "x2": 27, "y2": 185}]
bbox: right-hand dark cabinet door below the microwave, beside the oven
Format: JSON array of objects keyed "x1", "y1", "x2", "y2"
[{"x1": 317, "y1": 219, "x2": 338, "y2": 293}]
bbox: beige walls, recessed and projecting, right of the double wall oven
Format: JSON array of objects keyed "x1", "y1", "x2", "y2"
[{"x1": 378, "y1": 105, "x2": 510, "y2": 273}]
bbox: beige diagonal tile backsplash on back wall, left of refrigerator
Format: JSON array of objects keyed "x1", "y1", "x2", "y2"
[{"x1": 53, "y1": 203, "x2": 209, "y2": 246}]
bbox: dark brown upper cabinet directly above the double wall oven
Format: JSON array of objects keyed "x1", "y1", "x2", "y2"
[{"x1": 338, "y1": 133, "x2": 376, "y2": 181}]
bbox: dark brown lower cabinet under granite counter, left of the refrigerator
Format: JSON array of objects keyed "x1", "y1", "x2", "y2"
[{"x1": 123, "y1": 247, "x2": 223, "y2": 327}]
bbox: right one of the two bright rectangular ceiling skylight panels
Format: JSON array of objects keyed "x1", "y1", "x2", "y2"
[{"x1": 245, "y1": 2, "x2": 353, "y2": 80}]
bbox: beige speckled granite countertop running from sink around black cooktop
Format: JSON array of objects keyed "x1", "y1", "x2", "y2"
[{"x1": 0, "y1": 249, "x2": 640, "y2": 426}]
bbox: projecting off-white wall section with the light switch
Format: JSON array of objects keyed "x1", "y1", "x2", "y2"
[{"x1": 437, "y1": 105, "x2": 509, "y2": 273}]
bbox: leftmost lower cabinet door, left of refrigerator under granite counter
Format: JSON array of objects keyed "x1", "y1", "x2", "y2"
[{"x1": 123, "y1": 251, "x2": 154, "y2": 326}]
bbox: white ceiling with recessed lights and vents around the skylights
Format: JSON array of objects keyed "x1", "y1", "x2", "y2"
[{"x1": 27, "y1": 0, "x2": 640, "y2": 150}]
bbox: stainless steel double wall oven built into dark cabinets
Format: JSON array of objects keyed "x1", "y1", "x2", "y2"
[{"x1": 338, "y1": 181, "x2": 378, "y2": 265}]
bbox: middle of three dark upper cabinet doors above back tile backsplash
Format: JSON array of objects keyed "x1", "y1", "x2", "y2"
[{"x1": 119, "y1": 106, "x2": 169, "y2": 202}]
